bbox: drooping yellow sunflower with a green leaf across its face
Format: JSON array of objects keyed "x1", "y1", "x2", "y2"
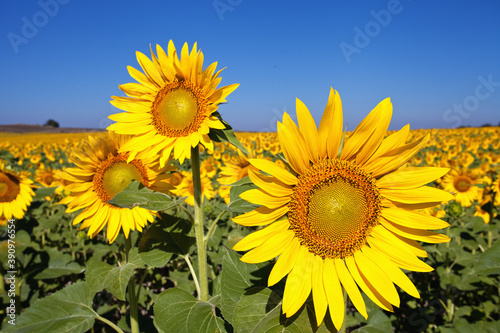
[{"x1": 60, "y1": 132, "x2": 173, "y2": 243}]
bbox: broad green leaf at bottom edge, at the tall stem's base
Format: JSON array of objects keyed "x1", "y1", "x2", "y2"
[{"x1": 154, "y1": 288, "x2": 226, "y2": 333}]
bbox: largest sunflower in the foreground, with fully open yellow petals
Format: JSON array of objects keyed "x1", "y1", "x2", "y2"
[{"x1": 234, "y1": 89, "x2": 452, "y2": 328}]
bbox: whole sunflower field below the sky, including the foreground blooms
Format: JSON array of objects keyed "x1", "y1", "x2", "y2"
[{"x1": 0, "y1": 43, "x2": 500, "y2": 333}]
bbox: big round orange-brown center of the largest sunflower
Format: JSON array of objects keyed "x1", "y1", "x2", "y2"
[{"x1": 288, "y1": 159, "x2": 381, "y2": 259}]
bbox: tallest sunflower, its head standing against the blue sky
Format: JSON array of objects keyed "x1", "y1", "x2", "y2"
[{"x1": 108, "y1": 41, "x2": 238, "y2": 166}]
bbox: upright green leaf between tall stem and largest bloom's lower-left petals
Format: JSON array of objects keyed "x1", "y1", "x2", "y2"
[{"x1": 220, "y1": 247, "x2": 265, "y2": 323}]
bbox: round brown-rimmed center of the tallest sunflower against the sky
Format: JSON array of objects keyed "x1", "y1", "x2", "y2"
[{"x1": 151, "y1": 81, "x2": 208, "y2": 137}]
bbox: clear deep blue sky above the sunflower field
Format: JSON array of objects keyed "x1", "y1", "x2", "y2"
[{"x1": 0, "y1": 0, "x2": 500, "y2": 131}]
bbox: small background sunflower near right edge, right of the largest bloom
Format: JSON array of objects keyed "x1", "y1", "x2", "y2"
[{"x1": 441, "y1": 168, "x2": 483, "y2": 207}]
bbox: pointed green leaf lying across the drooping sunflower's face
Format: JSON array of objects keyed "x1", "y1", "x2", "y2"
[{"x1": 108, "y1": 180, "x2": 184, "y2": 211}]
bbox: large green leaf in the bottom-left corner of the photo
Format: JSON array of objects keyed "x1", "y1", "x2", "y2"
[{"x1": 4, "y1": 282, "x2": 97, "y2": 333}]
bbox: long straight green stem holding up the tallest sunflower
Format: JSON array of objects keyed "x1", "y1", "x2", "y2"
[{"x1": 191, "y1": 146, "x2": 208, "y2": 302}]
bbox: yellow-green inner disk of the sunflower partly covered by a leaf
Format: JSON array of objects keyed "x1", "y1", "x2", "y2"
[{"x1": 102, "y1": 162, "x2": 142, "y2": 198}]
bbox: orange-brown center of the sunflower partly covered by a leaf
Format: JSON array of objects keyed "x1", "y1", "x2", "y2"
[{"x1": 94, "y1": 154, "x2": 148, "y2": 201}]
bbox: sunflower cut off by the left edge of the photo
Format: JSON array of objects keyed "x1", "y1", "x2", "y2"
[{"x1": 0, "y1": 163, "x2": 35, "y2": 220}]
